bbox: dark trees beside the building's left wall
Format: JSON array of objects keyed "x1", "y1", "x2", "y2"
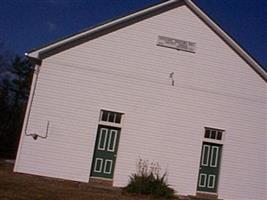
[{"x1": 0, "y1": 46, "x2": 33, "y2": 158}]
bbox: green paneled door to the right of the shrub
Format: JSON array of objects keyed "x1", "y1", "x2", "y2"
[{"x1": 197, "y1": 142, "x2": 222, "y2": 193}]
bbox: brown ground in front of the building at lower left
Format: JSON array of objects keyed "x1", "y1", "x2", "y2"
[{"x1": 0, "y1": 160, "x2": 159, "y2": 200}]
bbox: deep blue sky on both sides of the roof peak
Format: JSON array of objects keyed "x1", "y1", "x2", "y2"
[{"x1": 0, "y1": 0, "x2": 267, "y2": 69}]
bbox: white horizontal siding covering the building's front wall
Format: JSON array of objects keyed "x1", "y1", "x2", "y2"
[{"x1": 15, "y1": 6, "x2": 267, "y2": 200}]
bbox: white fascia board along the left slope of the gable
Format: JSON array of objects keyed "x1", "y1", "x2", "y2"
[{"x1": 25, "y1": 0, "x2": 181, "y2": 59}]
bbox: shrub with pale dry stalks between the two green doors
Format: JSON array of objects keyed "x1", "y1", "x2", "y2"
[{"x1": 124, "y1": 159, "x2": 175, "y2": 199}]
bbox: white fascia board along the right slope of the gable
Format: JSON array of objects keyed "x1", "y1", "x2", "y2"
[{"x1": 184, "y1": 0, "x2": 267, "y2": 81}]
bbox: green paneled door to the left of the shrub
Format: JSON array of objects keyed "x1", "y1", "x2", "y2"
[{"x1": 91, "y1": 125, "x2": 120, "y2": 179}]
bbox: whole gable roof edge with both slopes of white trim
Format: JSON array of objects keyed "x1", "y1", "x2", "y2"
[{"x1": 25, "y1": 0, "x2": 267, "y2": 82}]
